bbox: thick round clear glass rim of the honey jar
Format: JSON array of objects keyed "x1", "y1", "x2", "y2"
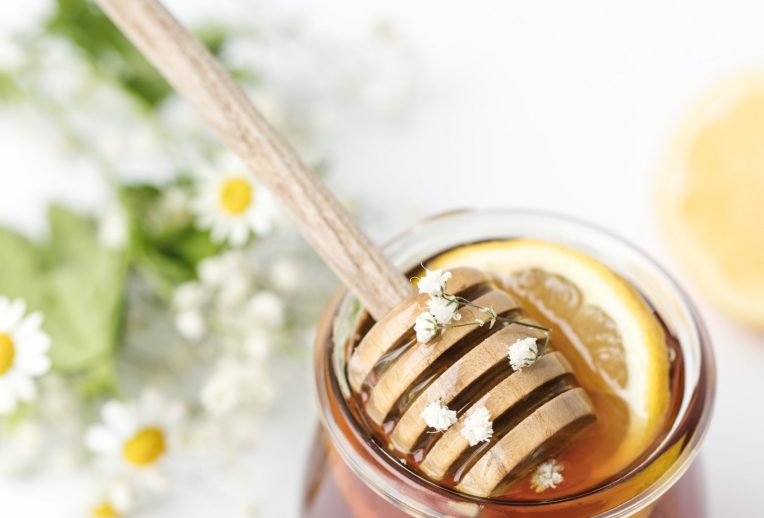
[{"x1": 316, "y1": 209, "x2": 716, "y2": 516}]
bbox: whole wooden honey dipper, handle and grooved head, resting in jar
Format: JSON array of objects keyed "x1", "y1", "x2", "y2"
[{"x1": 97, "y1": 0, "x2": 594, "y2": 496}]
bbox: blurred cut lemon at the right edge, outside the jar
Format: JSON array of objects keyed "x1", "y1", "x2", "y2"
[{"x1": 656, "y1": 73, "x2": 764, "y2": 328}]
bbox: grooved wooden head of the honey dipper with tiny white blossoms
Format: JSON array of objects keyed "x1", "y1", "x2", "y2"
[{"x1": 348, "y1": 268, "x2": 595, "y2": 497}]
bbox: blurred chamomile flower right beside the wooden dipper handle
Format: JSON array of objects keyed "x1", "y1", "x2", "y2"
[{"x1": 194, "y1": 155, "x2": 277, "y2": 247}]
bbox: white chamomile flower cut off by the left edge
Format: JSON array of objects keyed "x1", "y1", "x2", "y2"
[{"x1": 0, "y1": 297, "x2": 50, "y2": 414}]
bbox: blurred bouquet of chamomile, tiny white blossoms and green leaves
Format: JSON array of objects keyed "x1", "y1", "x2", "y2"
[{"x1": 0, "y1": 0, "x2": 412, "y2": 516}]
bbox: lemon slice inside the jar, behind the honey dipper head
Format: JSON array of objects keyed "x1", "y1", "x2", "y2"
[{"x1": 428, "y1": 239, "x2": 669, "y2": 469}]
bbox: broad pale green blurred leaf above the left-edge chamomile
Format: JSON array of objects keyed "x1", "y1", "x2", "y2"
[{"x1": 0, "y1": 206, "x2": 127, "y2": 391}]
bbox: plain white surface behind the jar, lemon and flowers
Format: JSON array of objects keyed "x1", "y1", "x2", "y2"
[{"x1": 0, "y1": 0, "x2": 764, "y2": 516}]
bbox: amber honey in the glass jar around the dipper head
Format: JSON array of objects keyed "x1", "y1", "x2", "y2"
[{"x1": 305, "y1": 212, "x2": 710, "y2": 517}]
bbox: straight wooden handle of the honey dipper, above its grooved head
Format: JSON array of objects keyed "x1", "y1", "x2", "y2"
[{"x1": 97, "y1": 0, "x2": 418, "y2": 319}]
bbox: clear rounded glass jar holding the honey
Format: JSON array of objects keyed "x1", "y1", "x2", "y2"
[{"x1": 303, "y1": 210, "x2": 715, "y2": 518}]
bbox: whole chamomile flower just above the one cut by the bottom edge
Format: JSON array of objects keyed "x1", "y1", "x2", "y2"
[{"x1": 85, "y1": 391, "x2": 183, "y2": 490}]
